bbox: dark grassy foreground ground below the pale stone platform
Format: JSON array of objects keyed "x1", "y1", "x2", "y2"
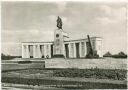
[{"x1": 2, "y1": 68, "x2": 127, "y2": 89}]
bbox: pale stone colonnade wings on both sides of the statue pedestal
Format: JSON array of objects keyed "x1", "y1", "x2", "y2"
[{"x1": 22, "y1": 38, "x2": 103, "y2": 58}]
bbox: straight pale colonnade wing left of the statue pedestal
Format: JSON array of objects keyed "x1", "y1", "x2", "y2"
[{"x1": 22, "y1": 44, "x2": 52, "y2": 58}]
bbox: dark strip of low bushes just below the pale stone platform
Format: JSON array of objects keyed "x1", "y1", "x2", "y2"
[{"x1": 53, "y1": 68, "x2": 127, "y2": 80}]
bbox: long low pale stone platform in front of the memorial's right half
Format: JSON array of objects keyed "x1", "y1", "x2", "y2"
[{"x1": 45, "y1": 58, "x2": 127, "y2": 69}]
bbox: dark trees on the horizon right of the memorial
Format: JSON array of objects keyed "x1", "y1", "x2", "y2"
[{"x1": 103, "y1": 52, "x2": 127, "y2": 58}]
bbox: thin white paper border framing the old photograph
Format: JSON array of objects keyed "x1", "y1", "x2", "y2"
[{"x1": 0, "y1": 0, "x2": 128, "y2": 90}]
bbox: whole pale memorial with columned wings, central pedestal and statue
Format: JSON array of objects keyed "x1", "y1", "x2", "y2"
[{"x1": 22, "y1": 16, "x2": 103, "y2": 58}]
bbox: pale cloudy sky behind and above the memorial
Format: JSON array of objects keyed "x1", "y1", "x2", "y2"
[{"x1": 1, "y1": 1, "x2": 127, "y2": 55}]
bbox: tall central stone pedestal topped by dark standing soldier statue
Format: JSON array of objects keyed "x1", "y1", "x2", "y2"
[{"x1": 53, "y1": 16, "x2": 65, "y2": 57}]
